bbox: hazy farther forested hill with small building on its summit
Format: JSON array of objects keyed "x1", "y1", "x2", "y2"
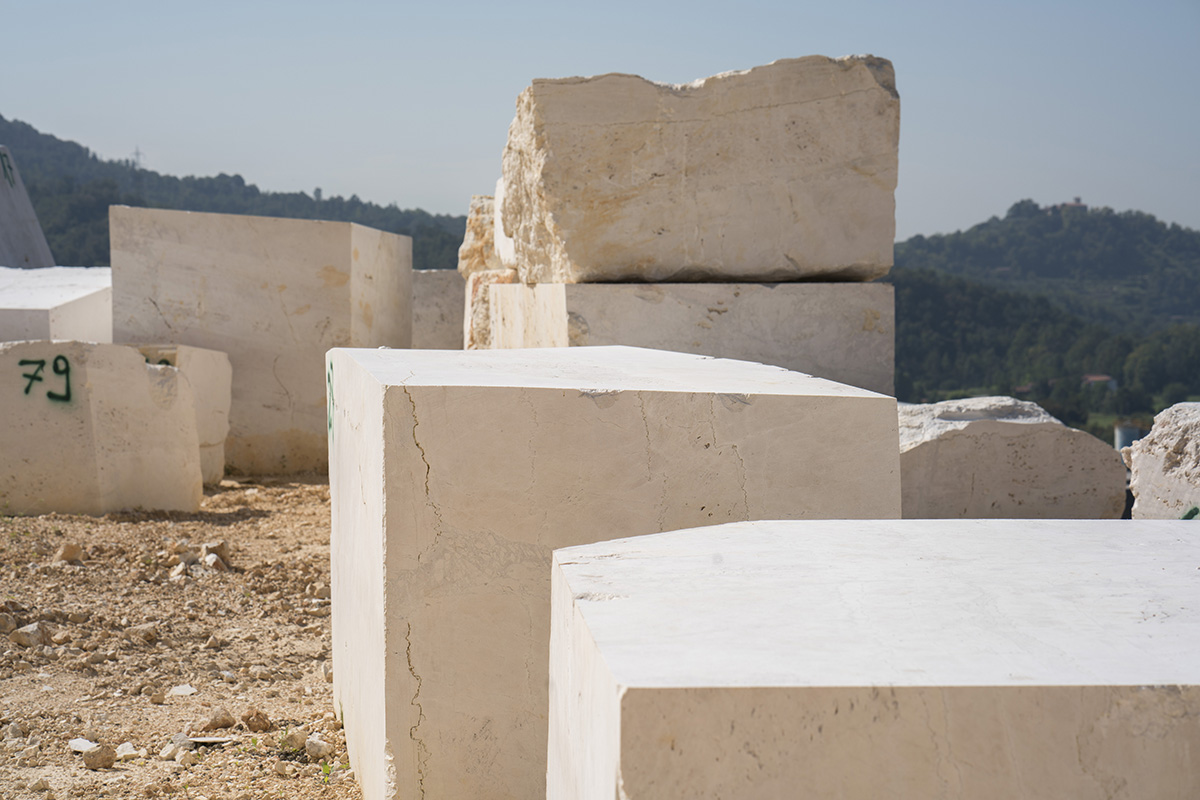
[{"x1": 895, "y1": 200, "x2": 1200, "y2": 333}]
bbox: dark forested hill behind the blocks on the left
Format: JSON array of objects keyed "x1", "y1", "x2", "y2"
[{"x1": 0, "y1": 116, "x2": 469, "y2": 270}]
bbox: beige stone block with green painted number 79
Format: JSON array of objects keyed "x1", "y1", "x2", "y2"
[{"x1": 0, "y1": 342, "x2": 203, "y2": 515}]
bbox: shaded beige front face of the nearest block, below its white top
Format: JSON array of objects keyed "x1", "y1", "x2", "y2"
[{"x1": 619, "y1": 686, "x2": 1200, "y2": 800}]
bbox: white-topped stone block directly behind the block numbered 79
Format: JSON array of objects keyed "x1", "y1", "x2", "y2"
[{"x1": 0, "y1": 266, "x2": 113, "y2": 343}]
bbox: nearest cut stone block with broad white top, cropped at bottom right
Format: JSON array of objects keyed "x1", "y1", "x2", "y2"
[{"x1": 546, "y1": 521, "x2": 1200, "y2": 800}]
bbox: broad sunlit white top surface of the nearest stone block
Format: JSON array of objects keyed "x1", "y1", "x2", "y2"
[{"x1": 554, "y1": 519, "x2": 1200, "y2": 687}]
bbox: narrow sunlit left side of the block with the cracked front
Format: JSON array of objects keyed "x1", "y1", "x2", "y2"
[{"x1": 325, "y1": 350, "x2": 393, "y2": 800}]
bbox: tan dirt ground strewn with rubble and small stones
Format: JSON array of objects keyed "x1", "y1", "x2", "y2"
[{"x1": 0, "y1": 479, "x2": 361, "y2": 800}]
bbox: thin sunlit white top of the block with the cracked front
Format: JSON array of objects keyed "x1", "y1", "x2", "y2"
[{"x1": 333, "y1": 345, "x2": 886, "y2": 403}]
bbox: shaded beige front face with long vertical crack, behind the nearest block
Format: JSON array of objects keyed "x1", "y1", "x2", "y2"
[{"x1": 374, "y1": 386, "x2": 900, "y2": 798}]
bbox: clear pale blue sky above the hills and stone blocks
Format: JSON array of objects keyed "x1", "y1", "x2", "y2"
[{"x1": 0, "y1": 0, "x2": 1200, "y2": 240}]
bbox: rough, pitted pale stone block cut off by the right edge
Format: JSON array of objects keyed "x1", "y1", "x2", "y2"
[{"x1": 1121, "y1": 403, "x2": 1200, "y2": 519}]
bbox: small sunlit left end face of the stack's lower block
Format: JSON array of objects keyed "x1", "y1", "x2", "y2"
[{"x1": 488, "y1": 283, "x2": 569, "y2": 349}]
